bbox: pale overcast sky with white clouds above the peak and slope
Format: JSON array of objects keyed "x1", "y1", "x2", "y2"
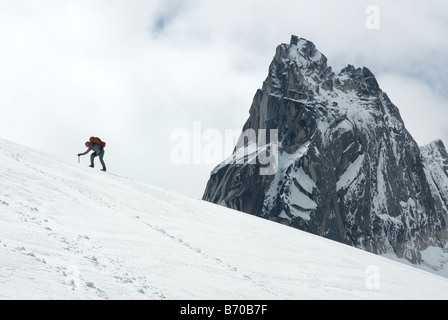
[{"x1": 0, "y1": 0, "x2": 448, "y2": 198}]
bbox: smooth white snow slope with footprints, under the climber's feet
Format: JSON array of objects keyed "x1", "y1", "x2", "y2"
[{"x1": 0, "y1": 140, "x2": 448, "y2": 300}]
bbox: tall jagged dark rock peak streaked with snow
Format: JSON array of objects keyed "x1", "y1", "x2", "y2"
[{"x1": 203, "y1": 36, "x2": 448, "y2": 263}]
